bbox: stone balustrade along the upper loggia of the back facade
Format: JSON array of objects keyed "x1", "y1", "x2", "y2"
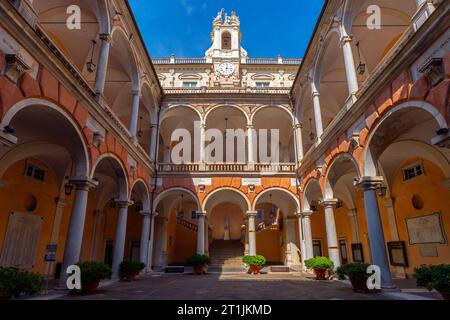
[{"x1": 158, "y1": 163, "x2": 295, "y2": 175}]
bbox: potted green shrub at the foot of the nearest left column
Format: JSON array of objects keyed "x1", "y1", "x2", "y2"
[{"x1": 76, "y1": 261, "x2": 112, "y2": 293}]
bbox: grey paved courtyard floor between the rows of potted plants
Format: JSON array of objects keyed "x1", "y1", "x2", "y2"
[{"x1": 41, "y1": 273, "x2": 440, "y2": 300}]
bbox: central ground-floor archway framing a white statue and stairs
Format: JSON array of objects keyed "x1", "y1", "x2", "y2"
[{"x1": 204, "y1": 189, "x2": 249, "y2": 271}]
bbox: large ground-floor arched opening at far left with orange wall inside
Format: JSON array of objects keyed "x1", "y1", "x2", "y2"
[{"x1": 0, "y1": 99, "x2": 89, "y2": 274}]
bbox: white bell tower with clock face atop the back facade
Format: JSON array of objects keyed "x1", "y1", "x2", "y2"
[{"x1": 205, "y1": 9, "x2": 247, "y2": 87}]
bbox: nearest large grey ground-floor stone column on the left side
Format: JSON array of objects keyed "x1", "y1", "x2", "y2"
[{"x1": 61, "y1": 177, "x2": 98, "y2": 286}]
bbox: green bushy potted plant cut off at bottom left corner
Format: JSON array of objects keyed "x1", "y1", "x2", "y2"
[{"x1": 0, "y1": 267, "x2": 44, "y2": 300}]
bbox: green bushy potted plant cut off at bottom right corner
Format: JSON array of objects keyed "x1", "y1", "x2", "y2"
[{"x1": 414, "y1": 264, "x2": 450, "y2": 300}]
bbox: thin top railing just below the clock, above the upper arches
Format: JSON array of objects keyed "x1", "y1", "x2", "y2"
[{"x1": 164, "y1": 87, "x2": 290, "y2": 94}]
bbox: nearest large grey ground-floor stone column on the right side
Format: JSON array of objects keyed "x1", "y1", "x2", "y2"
[{"x1": 359, "y1": 177, "x2": 395, "y2": 288}]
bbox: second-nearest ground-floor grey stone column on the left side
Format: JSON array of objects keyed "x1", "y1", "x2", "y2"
[{"x1": 112, "y1": 201, "x2": 133, "y2": 277}]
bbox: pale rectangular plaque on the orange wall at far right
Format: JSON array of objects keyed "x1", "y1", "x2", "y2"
[{"x1": 405, "y1": 212, "x2": 447, "y2": 244}]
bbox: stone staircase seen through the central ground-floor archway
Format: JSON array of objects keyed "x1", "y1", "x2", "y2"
[{"x1": 208, "y1": 240, "x2": 245, "y2": 272}]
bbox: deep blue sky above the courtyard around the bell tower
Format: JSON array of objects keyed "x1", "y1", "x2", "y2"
[{"x1": 130, "y1": 0, "x2": 324, "y2": 58}]
